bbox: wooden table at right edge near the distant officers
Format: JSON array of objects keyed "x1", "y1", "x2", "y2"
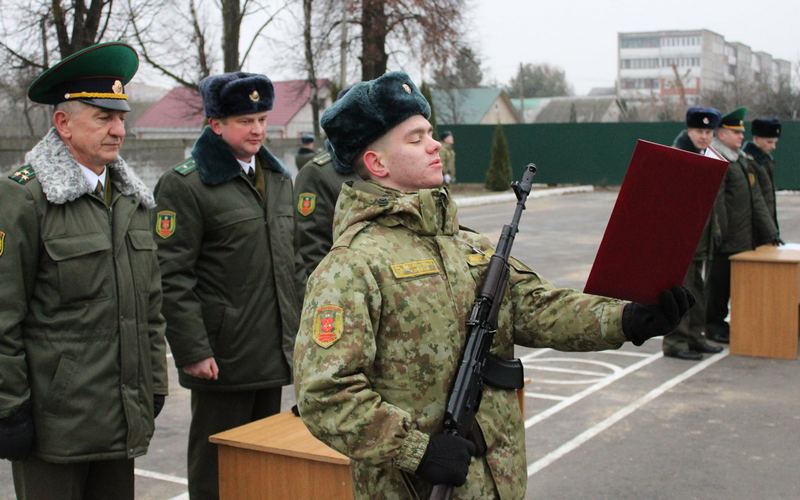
[{"x1": 730, "y1": 245, "x2": 800, "y2": 359}]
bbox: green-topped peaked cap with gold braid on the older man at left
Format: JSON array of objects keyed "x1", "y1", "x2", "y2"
[{"x1": 28, "y1": 42, "x2": 139, "y2": 111}]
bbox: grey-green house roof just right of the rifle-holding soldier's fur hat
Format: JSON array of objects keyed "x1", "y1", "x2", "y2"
[{"x1": 431, "y1": 87, "x2": 504, "y2": 123}]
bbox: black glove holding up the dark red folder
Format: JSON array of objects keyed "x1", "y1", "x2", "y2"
[{"x1": 622, "y1": 286, "x2": 695, "y2": 345}]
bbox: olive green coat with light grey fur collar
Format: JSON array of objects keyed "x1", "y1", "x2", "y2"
[{"x1": 0, "y1": 129, "x2": 167, "y2": 463}]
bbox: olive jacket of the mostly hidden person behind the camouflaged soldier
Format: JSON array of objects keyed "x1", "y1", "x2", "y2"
[{"x1": 294, "y1": 152, "x2": 359, "y2": 285}]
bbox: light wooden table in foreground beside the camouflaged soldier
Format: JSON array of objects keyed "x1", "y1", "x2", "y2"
[{"x1": 210, "y1": 410, "x2": 353, "y2": 500}]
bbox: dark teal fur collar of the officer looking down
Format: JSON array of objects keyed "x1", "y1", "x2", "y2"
[{"x1": 192, "y1": 126, "x2": 289, "y2": 185}]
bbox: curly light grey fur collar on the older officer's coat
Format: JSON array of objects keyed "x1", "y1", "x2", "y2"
[{"x1": 25, "y1": 128, "x2": 156, "y2": 208}]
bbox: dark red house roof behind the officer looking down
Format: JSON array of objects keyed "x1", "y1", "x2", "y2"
[{"x1": 133, "y1": 79, "x2": 330, "y2": 129}]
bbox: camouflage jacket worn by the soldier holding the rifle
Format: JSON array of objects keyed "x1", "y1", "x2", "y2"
[{"x1": 295, "y1": 182, "x2": 626, "y2": 499}]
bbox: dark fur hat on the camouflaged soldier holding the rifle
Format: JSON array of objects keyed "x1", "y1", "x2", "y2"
[{"x1": 321, "y1": 71, "x2": 431, "y2": 169}]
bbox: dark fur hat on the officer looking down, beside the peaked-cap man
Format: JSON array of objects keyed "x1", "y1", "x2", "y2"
[{"x1": 200, "y1": 71, "x2": 275, "y2": 118}]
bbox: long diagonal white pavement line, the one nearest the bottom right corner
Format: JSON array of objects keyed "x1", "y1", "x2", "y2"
[{"x1": 528, "y1": 348, "x2": 729, "y2": 477}]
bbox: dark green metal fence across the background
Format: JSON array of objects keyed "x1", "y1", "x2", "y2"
[{"x1": 439, "y1": 122, "x2": 800, "y2": 189}]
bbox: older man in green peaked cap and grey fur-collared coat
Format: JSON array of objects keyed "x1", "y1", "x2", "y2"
[{"x1": 0, "y1": 42, "x2": 167, "y2": 499}]
